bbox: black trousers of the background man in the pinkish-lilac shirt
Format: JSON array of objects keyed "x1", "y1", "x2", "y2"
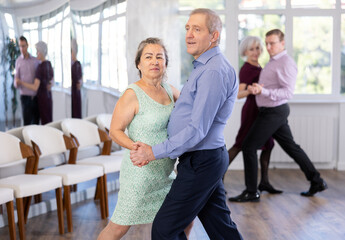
[{"x1": 242, "y1": 104, "x2": 321, "y2": 192}]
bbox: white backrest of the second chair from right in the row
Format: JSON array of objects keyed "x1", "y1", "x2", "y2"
[{"x1": 61, "y1": 118, "x2": 101, "y2": 148}]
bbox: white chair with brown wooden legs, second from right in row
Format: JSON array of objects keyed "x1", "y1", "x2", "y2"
[{"x1": 61, "y1": 119, "x2": 122, "y2": 217}]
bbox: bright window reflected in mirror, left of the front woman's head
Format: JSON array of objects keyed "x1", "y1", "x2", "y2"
[{"x1": 72, "y1": 0, "x2": 128, "y2": 91}]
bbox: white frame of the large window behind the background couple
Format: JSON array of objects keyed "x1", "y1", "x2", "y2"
[{"x1": 179, "y1": 0, "x2": 345, "y2": 101}]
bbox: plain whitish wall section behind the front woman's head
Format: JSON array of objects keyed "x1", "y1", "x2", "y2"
[{"x1": 127, "y1": 0, "x2": 181, "y2": 87}]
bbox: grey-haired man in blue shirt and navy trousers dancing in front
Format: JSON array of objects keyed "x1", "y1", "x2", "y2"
[{"x1": 131, "y1": 9, "x2": 242, "y2": 240}]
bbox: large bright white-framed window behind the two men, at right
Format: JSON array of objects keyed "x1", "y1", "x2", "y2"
[{"x1": 179, "y1": 0, "x2": 345, "y2": 97}]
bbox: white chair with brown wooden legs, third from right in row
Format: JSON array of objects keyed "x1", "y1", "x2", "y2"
[{"x1": 23, "y1": 125, "x2": 106, "y2": 232}]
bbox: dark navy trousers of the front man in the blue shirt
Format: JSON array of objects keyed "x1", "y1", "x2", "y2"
[{"x1": 152, "y1": 146, "x2": 242, "y2": 240}]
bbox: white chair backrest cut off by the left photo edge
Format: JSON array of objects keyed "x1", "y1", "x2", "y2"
[{"x1": 0, "y1": 132, "x2": 24, "y2": 166}]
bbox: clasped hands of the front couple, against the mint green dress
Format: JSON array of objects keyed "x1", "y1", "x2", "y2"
[{"x1": 130, "y1": 142, "x2": 155, "y2": 167}]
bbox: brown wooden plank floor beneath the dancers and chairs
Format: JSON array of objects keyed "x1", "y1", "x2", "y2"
[{"x1": 0, "y1": 170, "x2": 345, "y2": 240}]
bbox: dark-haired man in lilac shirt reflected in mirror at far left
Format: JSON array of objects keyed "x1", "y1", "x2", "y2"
[{"x1": 14, "y1": 36, "x2": 39, "y2": 126}]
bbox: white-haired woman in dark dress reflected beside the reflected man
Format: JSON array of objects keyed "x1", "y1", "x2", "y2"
[{"x1": 17, "y1": 41, "x2": 54, "y2": 125}]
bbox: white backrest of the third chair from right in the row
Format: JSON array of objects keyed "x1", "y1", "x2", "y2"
[{"x1": 23, "y1": 125, "x2": 67, "y2": 157}]
